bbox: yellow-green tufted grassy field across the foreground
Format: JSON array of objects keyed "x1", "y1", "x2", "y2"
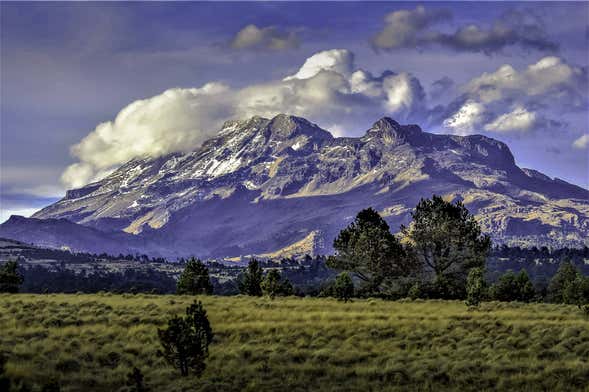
[{"x1": 0, "y1": 294, "x2": 589, "y2": 392}]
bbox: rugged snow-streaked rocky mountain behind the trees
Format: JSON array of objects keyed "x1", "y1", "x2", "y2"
[{"x1": 0, "y1": 114, "x2": 589, "y2": 257}]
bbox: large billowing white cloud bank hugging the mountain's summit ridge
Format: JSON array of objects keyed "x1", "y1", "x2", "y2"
[{"x1": 61, "y1": 49, "x2": 427, "y2": 188}]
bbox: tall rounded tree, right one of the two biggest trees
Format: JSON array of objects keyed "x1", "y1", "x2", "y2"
[{"x1": 401, "y1": 195, "x2": 491, "y2": 296}]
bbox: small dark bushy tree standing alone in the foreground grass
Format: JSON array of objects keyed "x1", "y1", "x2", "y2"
[{"x1": 157, "y1": 301, "x2": 213, "y2": 377}]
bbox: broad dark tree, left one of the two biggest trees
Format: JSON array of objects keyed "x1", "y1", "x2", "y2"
[{"x1": 327, "y1": 208, "x2": 414, "y2": 292}]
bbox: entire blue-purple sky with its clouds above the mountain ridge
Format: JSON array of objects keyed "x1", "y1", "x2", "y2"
[{"x1": 0, "y1": 2, "x2": 589, "y2": 221}]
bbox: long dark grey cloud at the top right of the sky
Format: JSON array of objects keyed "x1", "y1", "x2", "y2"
[{"x1": 372, "y1": 6, "x2": 558, "y2": 54}]
